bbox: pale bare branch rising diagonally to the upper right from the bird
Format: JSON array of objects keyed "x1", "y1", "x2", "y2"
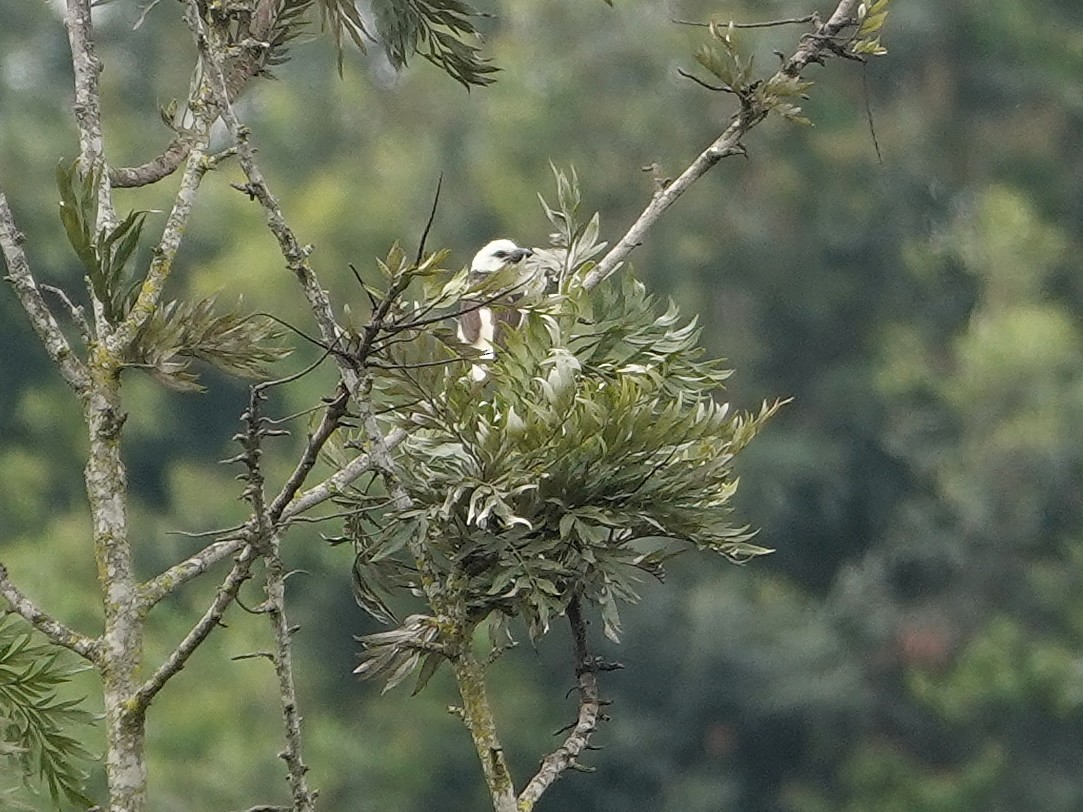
[{"x1": 583, "y1": 0, "x2": 858, "y2": 290}]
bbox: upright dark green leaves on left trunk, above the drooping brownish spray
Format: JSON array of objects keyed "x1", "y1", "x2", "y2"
[{"x1": 56, "y1": 161, "x2": 148, "y2": 324}]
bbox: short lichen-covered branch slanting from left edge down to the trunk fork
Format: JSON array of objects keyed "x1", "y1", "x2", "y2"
[{"x1": 0, "y1": 189, "x2": 90, "y2": 394}]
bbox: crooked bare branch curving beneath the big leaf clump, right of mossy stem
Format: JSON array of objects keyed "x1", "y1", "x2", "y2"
[{"x1": 519, "y1": 595, "x2": 601, "y2": 812}]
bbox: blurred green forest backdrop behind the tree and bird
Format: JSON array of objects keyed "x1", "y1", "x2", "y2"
[{"x1": 0, "y1": 0, "x2": 1083, "y2": 812}]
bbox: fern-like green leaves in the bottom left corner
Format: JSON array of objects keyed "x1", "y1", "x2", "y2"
[{"x1": 0, "y1": 613, "x2": 93, "y2": 808}]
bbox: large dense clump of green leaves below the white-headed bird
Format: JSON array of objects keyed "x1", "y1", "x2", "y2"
[{"x1": 344, "y1": 176, "x2": 778, "y2": 681}]
